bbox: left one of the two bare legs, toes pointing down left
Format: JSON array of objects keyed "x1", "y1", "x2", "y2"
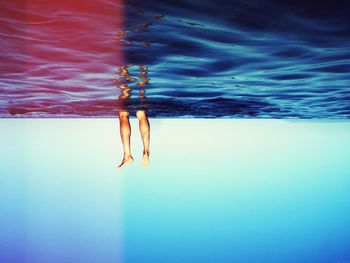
[{"x1": 118, "y1": 111, "x2": 133, "y2": 168}]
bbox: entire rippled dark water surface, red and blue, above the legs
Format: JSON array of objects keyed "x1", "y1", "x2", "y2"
[{"x1": 0, "y1": 0, "x2": 350, "y2": 118}]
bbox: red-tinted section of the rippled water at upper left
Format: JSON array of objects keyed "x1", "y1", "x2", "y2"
[{"x1": 0, "y1": 0, "x2": 123, "y2": 115}]
